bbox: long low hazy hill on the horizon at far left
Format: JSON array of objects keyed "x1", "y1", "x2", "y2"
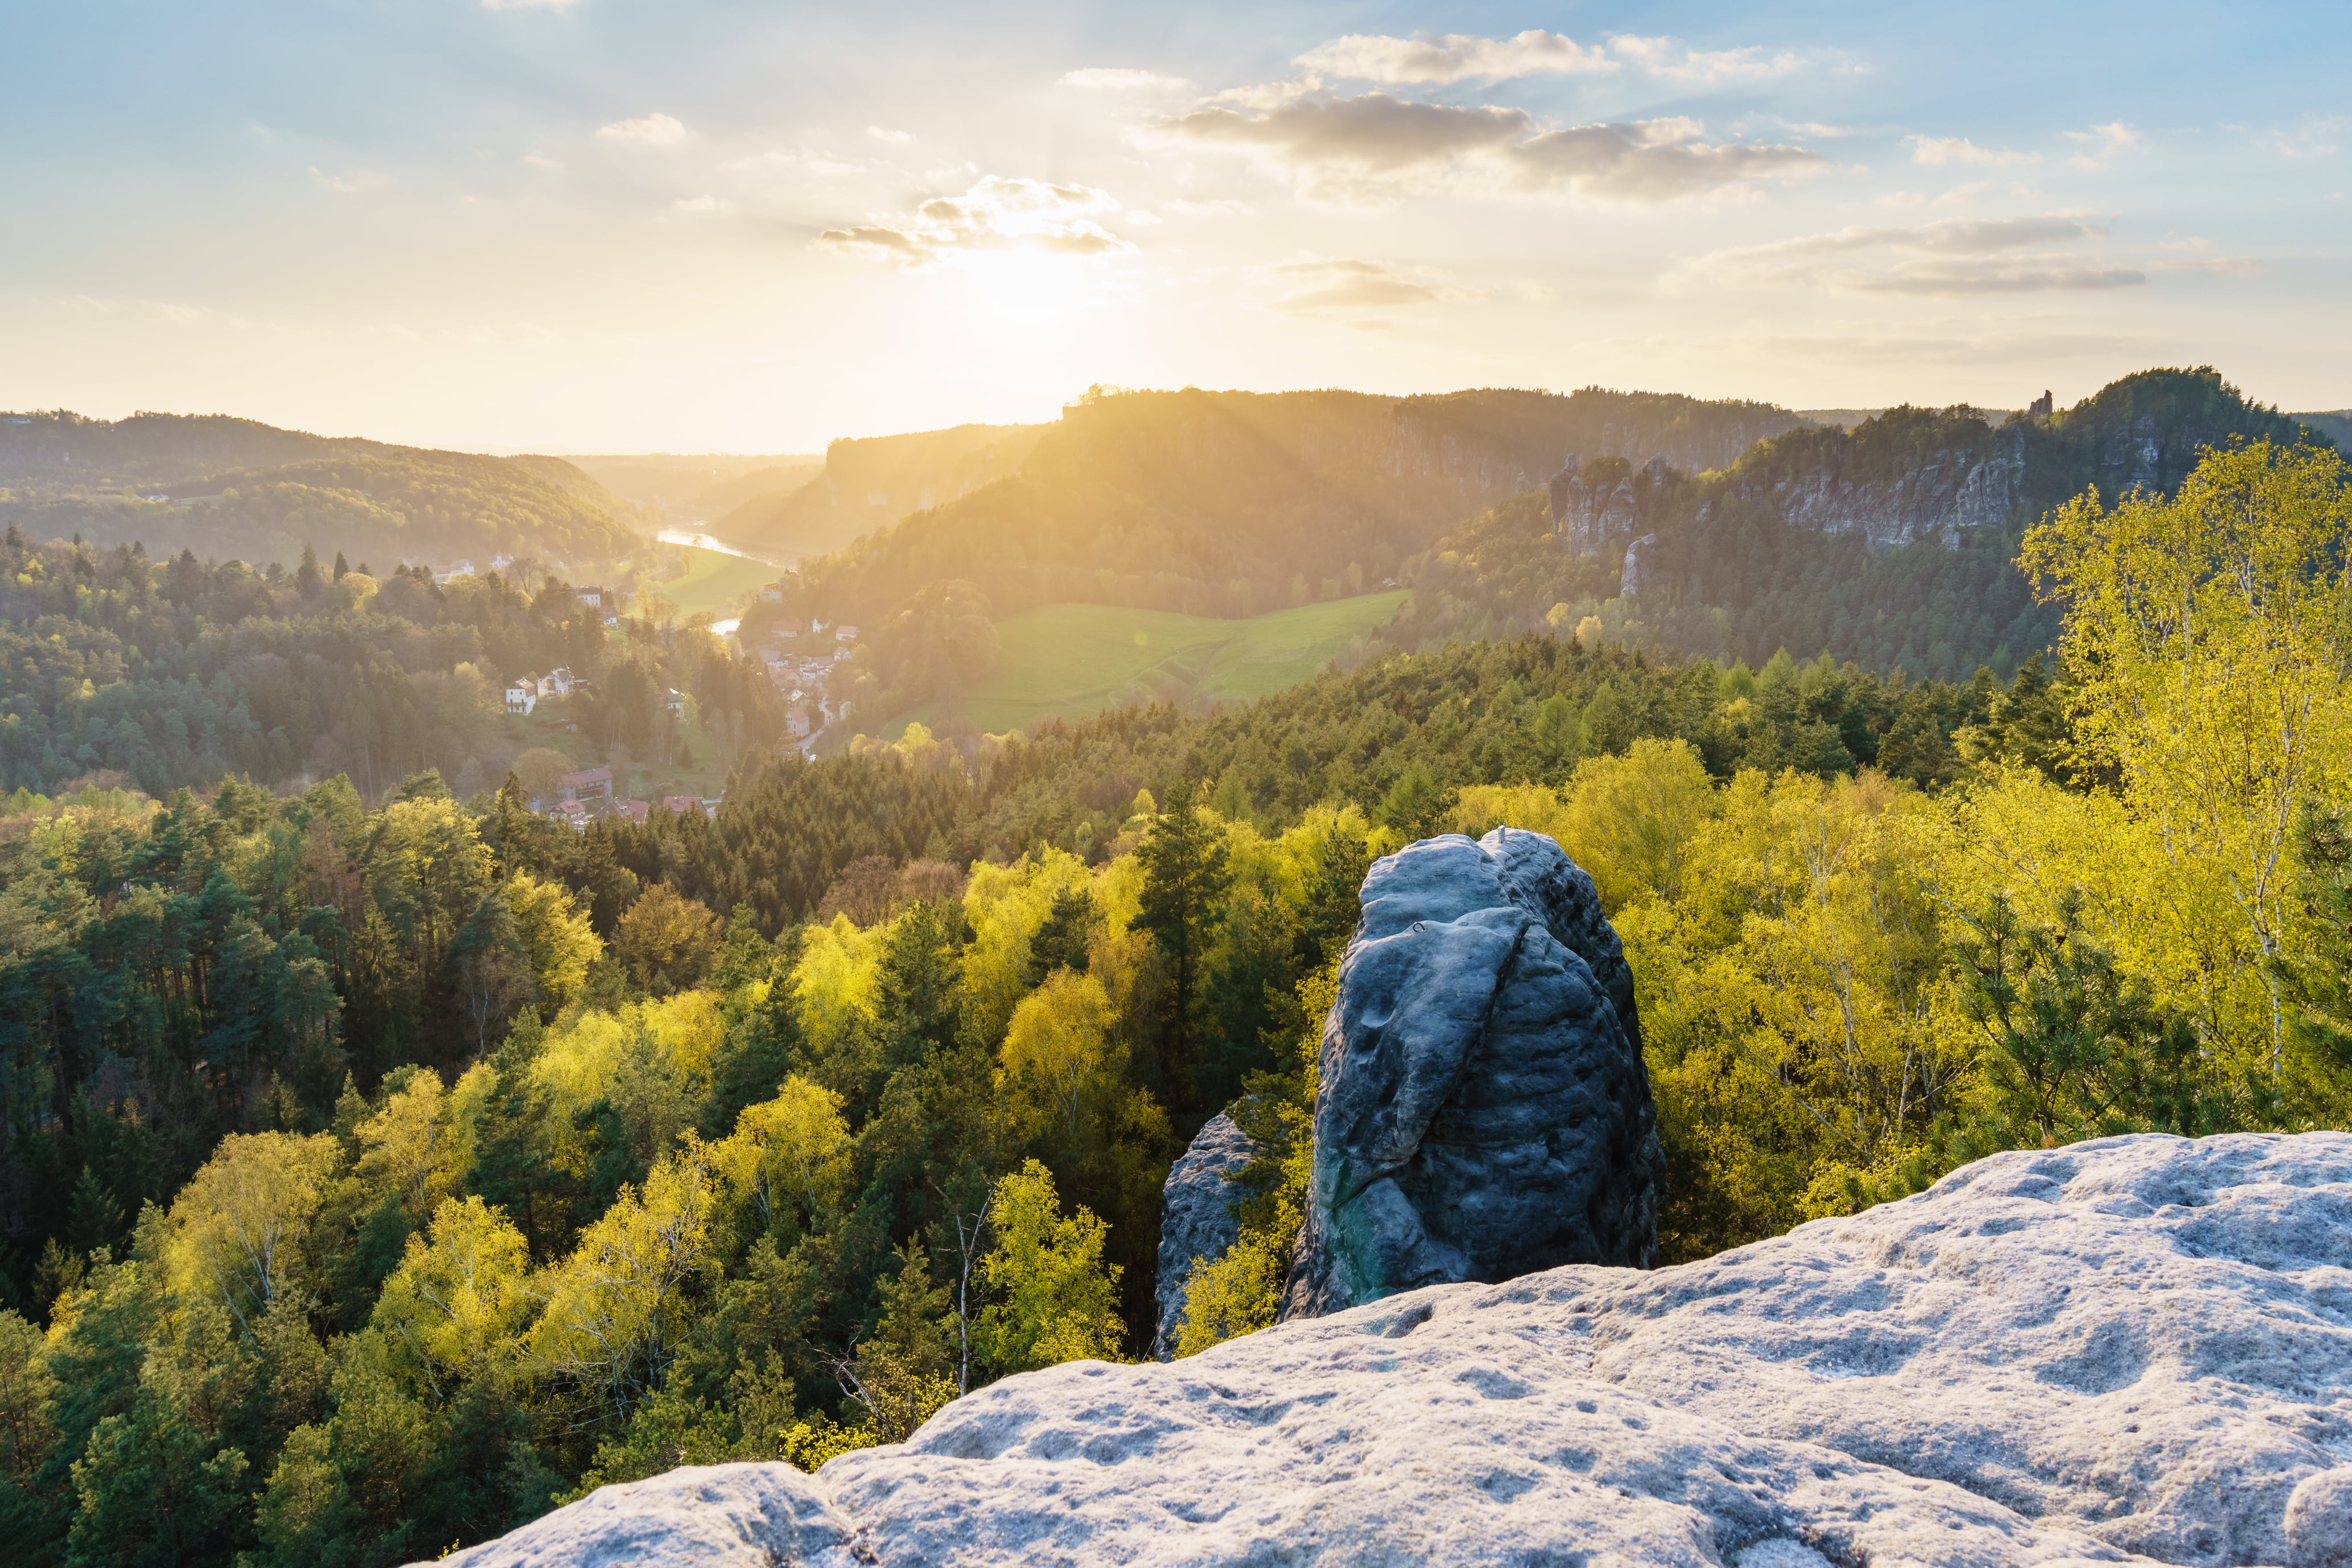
[{"x1": 0, "y1": 412, "x2": 642, "y2": 571}]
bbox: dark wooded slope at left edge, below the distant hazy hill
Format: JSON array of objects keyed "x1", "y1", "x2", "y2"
[{"x1": 0, "y1": 524, "x2": 783, "y2": 799}]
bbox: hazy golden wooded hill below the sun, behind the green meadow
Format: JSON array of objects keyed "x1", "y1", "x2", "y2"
[{"x1": 793, "y1": 388, "x2": 1802, "y2": 623}]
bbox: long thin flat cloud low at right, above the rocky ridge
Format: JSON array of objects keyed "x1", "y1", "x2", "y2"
[{"x1": 1670, "y1": 212, "x2": 2189, "y2": 294}]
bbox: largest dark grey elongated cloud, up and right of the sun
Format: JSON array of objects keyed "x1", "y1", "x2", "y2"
[{"x1": 1152, "y1": 92, "x2": 1827, "y2": 202}]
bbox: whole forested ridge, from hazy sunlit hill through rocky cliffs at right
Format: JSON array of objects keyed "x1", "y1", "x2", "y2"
[{"x1": 778, "y1": 367, "x2": 2333, "y2": 726}]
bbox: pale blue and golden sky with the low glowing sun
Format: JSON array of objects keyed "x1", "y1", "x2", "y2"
[{"x1": 0, "y1": 0, "x2": 2352, "y2": 454}]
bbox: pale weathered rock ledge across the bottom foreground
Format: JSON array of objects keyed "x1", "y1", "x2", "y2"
[{"x1": 428, "y1": 1133, "x2": 2352, "y2": 1568}]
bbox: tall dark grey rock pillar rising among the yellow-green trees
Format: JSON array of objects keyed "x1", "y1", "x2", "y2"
[{"x1": 1282, "y1": 827, "x2": 1663, "y2": 1319}]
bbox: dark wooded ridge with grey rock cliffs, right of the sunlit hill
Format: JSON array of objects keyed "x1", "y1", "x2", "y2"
[{"x1": 1392, "y1": 367, "x2": 2312, "y2": 680}]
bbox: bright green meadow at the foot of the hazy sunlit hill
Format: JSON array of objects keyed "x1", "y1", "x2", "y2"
[{"x1": 884, "y1": 592, "x2": 1407, "y2": 738}]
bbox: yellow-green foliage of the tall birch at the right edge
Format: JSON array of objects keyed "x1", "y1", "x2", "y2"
[{"x1": 2023, "y1": 442, "x2": 2352, "y2": 1072}]
